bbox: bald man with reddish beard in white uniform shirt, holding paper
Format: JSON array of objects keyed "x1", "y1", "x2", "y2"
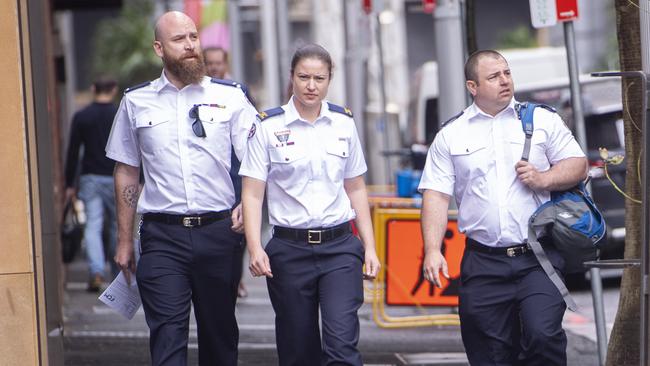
[{"x1": 106, "y1": 11, "x2": 257, "y2": 366}]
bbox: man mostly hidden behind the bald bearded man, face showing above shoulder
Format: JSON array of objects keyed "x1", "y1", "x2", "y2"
[{"x1": 203, "y1": 47, "x2": 248, "y2": 297}]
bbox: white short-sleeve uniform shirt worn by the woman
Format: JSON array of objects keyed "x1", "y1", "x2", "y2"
[{"x1": 239, "y1": 99, "x2": 367, "y2": 229}]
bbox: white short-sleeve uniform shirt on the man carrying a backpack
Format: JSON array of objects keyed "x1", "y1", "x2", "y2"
[{"x1": 418, "y1": 98, "x2": 585, "y2": 246}]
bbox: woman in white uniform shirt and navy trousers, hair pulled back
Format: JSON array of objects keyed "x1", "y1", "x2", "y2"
[{"x1": 239, "y1": 44, "x2": 379, "y2": 365}]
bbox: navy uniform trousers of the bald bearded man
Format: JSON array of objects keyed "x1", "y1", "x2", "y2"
[{"x1": 136, "y1": 218, "x2": 243, "y2": 366}]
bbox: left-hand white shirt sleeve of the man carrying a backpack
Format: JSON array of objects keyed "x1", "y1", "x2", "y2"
[{"x1": 418, "y1": 131, "x2": 456, "y2": 196}]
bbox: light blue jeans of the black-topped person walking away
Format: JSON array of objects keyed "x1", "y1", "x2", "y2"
[{"x1": 79, "y1": 174, "x2": 119, "y2": 278}]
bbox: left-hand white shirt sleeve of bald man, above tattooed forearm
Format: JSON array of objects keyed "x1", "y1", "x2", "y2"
[{"x1": 106, "y1": 96, "x2": 140, "y2": 167}]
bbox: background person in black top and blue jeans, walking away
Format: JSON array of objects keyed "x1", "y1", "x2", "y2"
[{"x1": 65, "y1": 77, "x2": 119, "y2": 292}]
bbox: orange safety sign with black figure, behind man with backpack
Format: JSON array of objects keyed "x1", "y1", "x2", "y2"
[{"x1": 385, "y1": 219, "x2": 465, "y2": 306}]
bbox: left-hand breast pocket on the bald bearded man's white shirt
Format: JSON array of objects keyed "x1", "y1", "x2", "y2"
[{"x1": 135, "y1": 111, "x2": 176, "y2": 153}]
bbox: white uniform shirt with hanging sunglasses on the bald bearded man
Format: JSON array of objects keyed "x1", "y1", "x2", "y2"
[{"x1": 106, "y1": 72, "x2": 257, "y2": 214}]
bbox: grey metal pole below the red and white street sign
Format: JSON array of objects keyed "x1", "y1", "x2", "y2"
[{"x1": 564, "y1": 21, "x2": 587, "y2": 151}]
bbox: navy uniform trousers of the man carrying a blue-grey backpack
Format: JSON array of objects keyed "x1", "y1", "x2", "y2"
[{"x1": 459, "y1": 239, "x2": 567, "y2": 366}]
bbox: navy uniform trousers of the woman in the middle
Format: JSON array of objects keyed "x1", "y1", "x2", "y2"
[{"x1": 265, "y1": 234, "x2": 364, "y2": 366}]
